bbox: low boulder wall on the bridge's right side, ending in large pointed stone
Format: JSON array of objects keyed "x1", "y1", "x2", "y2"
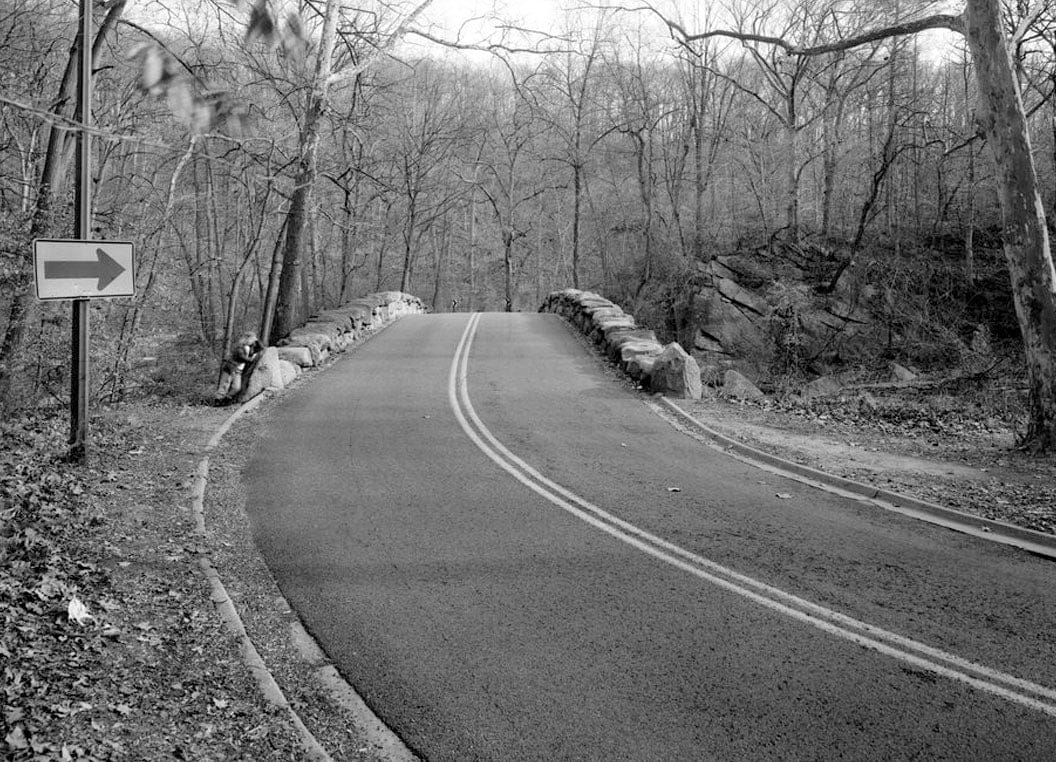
[{"x1": 539, "y1": 288, "x2": 702, "y2": 399}]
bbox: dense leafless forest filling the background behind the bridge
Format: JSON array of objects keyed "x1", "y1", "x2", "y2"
[{"x1": 0, "y1": 0, "x2": 1056, "y2": 446}]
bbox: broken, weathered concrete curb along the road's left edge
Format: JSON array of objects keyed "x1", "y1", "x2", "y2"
[{"x1": 191, "y1": 318, "x2": 417, "y2": 762}]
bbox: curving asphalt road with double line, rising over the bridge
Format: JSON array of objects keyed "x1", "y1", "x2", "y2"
[{"x1": 246, "y1": 313, "x2": 1056, "y2": 760}]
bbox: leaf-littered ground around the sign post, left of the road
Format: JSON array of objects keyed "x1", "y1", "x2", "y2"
[{"x1": 0, "y1": 408, "x2": 304, "y2": 762}]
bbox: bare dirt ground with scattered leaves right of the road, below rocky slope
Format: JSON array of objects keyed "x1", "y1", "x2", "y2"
[{"x1": 682, "y1": 395, "x2": 1056, "y2": 534}]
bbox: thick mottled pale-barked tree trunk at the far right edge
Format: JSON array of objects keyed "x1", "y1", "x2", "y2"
[{"x1": 965, "y1": 0, "x2": 1056, "y2": 450}]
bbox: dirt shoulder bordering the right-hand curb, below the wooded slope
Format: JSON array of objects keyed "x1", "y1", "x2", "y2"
[{"x1": 665, "y1": 398, "x2": 1056, "y2": 555}]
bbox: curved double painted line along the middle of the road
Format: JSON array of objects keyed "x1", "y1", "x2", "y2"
[{"x1": 448, "y1": 312, "x2": 1056, "y2": 718}]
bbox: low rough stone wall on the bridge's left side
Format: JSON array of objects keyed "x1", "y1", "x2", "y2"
[{"x1": 239, "y1": 291, "x2": 426, "y2": 402}]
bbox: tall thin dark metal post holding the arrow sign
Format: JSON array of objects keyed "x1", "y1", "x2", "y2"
[{"x1": 67, "y1": 0, "x2": 92, "y2": 462}]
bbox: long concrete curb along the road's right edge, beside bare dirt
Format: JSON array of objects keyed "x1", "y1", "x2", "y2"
[{"x1": 655, "y1": 397, "x2": 1056, "y2": 560}]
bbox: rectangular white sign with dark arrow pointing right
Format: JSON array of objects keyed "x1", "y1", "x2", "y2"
[{"x1": 33, "y1": 240, "x2": 135, "y2": 300}]
